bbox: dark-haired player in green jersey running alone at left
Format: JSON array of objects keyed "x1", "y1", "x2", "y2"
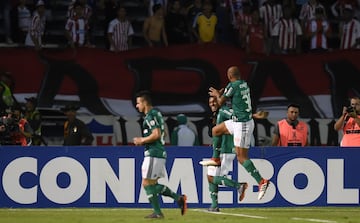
[{"x1": 133, "y1": 91, "x2": 187, "y2": 218}]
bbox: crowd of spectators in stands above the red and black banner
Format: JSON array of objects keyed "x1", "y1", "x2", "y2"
[{"x1": 1, "y1": 0, "x2": 360, "y2": 54}]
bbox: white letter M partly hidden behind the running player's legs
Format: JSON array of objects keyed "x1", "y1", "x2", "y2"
[{"x1": 138, "y1": 158, "x2": 199, "y2": 203}]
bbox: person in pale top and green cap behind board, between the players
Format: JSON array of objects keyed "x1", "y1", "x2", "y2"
[{"x1": 170, "y1": 114, "x2": 199, "y2": 146}]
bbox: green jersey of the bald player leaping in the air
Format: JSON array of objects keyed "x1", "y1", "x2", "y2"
[{"x1": 223, "y1": 80, "x2": 252, "y2": 122}]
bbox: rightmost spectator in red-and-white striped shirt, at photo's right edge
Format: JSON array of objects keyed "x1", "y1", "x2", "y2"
[{"x1": 339, "y1": 5, "x2": 360, "y2": 50}]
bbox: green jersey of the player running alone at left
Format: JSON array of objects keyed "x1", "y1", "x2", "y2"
[{"x1": 143, "y1": 108, "x2": 166, "y2": 158}]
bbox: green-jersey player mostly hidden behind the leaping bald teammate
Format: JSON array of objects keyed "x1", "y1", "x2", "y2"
[{"x1": 207, "y1": 97, "x2": 248, "y2": 212}]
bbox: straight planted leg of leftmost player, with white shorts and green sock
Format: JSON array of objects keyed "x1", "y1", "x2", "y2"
[{"x1": 141, "y1": 156, "x2": 164, "y2": 218}]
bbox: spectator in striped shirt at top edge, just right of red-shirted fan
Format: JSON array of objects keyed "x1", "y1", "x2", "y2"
[{"x1": 259, "y1": 0, "x2": 283, "y2": 53}]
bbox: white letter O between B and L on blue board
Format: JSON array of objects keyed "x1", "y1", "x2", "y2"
[{"x1": 277, "y1": 158, "x2": 325, "y2": 205}]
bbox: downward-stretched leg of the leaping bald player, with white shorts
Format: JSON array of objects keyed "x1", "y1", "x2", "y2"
[{"x1": 234, "y1": 120, "x2": 269, "y2": 200}]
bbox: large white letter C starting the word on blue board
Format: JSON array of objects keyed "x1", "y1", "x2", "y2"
[{"x1": 2, "y1": 157, "x2": 38, "y2": 204}]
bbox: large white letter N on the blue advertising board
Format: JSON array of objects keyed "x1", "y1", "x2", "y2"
[{"x1": 90, "y1": 158, "x2": 135, "y2": 203}]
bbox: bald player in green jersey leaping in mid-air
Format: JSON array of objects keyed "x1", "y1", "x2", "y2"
[{"x1": 209, "y1": 66, "x2": 270, "y2": 200}]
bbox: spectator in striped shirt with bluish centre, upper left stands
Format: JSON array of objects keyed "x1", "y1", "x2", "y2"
[{"x1": 65, "y1": 1, "x2": 87, "y2": 48}]
